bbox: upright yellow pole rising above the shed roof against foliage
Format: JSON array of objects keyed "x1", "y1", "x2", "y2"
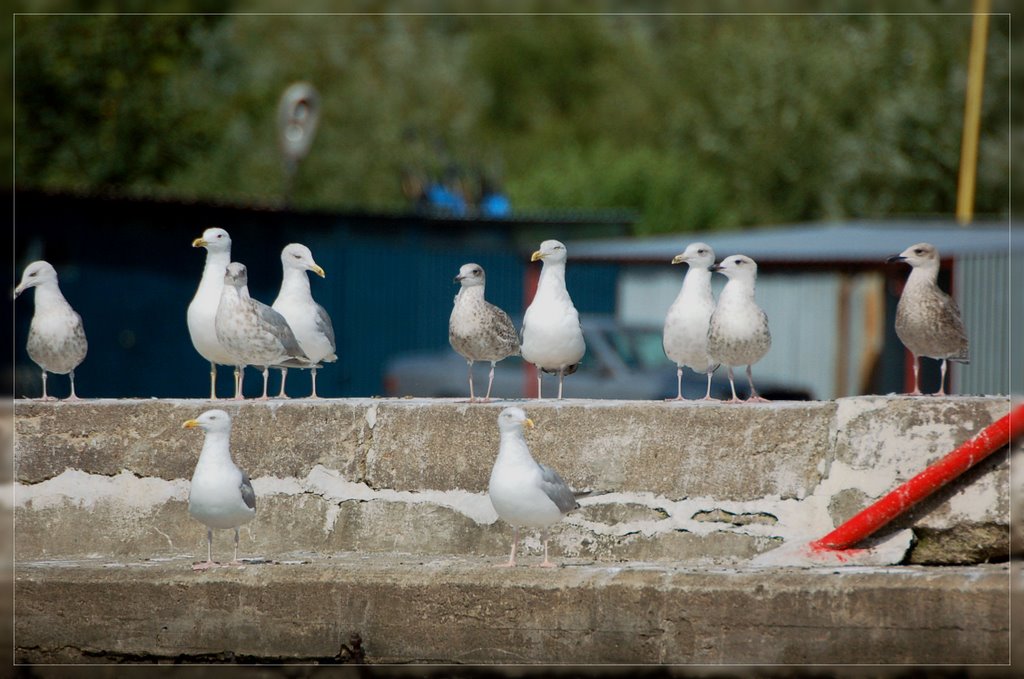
[{"x1": 956, "y1": 0, "x2": 990, "y2": 225}]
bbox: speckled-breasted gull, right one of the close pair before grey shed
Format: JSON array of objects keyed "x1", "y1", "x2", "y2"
[{"x1": 708, "y1": 255, "x2": 771, "y2": 404}]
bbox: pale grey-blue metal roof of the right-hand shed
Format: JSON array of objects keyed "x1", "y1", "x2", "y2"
[{"x1": 567, "y1": 219, "x2": 1024, "y2": 264}]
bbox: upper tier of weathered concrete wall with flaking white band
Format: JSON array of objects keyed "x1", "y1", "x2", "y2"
[{"x1": 13, "y1": 397, "x2": 1010, "y2": 563}]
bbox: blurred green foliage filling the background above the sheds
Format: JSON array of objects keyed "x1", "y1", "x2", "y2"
[{"x1": 14, "y1": 5, "x2": 1021, "y2": 232}]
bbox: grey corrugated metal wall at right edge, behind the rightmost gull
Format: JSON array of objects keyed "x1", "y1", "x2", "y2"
[{"x1": 953, "y1": 253, "x2": 1024, "y2": 394}]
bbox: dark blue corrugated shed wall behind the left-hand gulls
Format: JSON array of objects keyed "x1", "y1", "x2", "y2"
[{"x1": 13, "y1": 192, "x2": 617, "y2": 397}]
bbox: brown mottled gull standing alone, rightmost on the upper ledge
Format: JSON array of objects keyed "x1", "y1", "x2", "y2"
[{"x1": 887, "y1": 243, "x2": 970, "y2": 396}]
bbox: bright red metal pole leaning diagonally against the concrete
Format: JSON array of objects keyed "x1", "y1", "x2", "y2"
[{"x1": 811, "y1": 406, "x2": 1024, "y2": 550}]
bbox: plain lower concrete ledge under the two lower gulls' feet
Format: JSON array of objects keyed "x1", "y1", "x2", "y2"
[{"x1": 15, "y1": 555, "x2": 1010, "y2": 664}]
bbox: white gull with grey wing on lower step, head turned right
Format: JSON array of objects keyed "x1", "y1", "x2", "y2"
[{"x1": 487, "y1": 408, "x2": 586, "y2": 568}]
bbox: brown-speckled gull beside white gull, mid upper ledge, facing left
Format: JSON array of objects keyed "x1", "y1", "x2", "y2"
[{"x1": 449, "y1": 263, "x2": 519, "y2": 402}]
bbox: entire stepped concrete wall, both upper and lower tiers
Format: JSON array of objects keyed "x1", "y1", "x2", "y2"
[{"x1": 12, "y1": 397, "x2": 1019, "y2": 664}]
